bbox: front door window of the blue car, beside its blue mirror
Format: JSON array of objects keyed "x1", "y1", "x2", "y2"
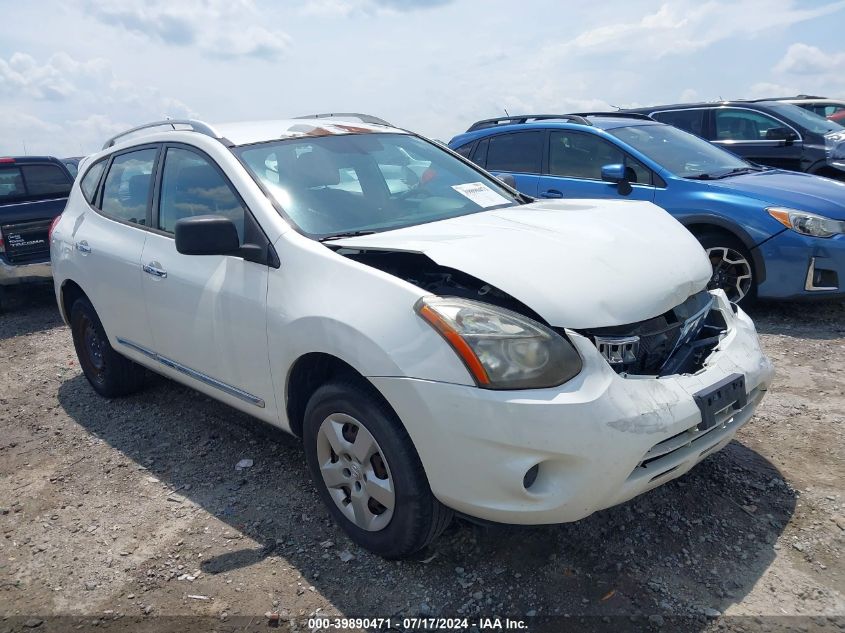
[{"x1": 549, "y1": 130, "x2": 651, "y2": 185}]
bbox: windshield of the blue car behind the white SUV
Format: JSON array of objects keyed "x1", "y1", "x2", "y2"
[{"x1": 607, "y1": 125, "x2": 755, "y2": 178}]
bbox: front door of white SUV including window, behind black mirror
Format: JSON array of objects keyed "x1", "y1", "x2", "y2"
[{"x1": 141, "y1": 144, "x2": 275, "y2": 414}]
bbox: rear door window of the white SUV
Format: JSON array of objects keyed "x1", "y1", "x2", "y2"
[{"x1": 100, "y1": 148, "x2": 158, "y2": 224}]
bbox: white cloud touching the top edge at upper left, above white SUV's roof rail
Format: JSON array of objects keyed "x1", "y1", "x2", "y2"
[{"x1": 88, "y1": 0, "x2": 290, "y2": 61}]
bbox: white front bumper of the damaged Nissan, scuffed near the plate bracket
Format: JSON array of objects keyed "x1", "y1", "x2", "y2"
[{"x1": 370, "y1": 292, "x2": 773, "y2": 524}]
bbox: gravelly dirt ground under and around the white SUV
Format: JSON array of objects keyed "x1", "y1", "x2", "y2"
[{"x1": 0, "y1": 290, "x2": 845, "y2": 633}]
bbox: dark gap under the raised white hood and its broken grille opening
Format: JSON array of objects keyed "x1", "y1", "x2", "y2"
[{"x1": 337, "y1": 248, "x2": 727, "y2": 376}]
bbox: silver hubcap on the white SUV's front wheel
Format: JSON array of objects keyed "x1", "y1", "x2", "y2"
[{"x1": 317, "y1": 413, "x2": 396, "y2": 532}]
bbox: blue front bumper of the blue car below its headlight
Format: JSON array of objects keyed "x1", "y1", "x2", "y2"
[{"x1": 757, "y1": 230, "x2": 845, "y2": 299}]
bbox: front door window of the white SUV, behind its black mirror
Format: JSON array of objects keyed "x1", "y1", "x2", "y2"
[{"x1": 158, "y1": 147, "x2": 245, "y2": 244}]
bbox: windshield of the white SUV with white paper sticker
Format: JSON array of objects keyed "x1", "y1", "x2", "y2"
[{"x1": 235, "y1": 134, "x2": 518, "y2": 239}]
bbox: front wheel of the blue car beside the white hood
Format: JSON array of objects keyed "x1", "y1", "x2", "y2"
[{"x1": 696, "y1": 233, "x2": 757, "y2": 306}]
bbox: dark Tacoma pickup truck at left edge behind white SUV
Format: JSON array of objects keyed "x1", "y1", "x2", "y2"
[{"x1": 0, "y1": 156, "x2": 73, "y2": 306}]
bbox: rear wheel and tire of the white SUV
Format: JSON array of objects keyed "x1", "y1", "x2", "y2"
[{"x1": 70, "y1": 297, "x2": 146, "y2": 398}]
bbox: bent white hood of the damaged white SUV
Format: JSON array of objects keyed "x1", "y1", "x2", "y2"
[{"x1": 331, "y1": 200, "x2": 712, "y2": 329}]
